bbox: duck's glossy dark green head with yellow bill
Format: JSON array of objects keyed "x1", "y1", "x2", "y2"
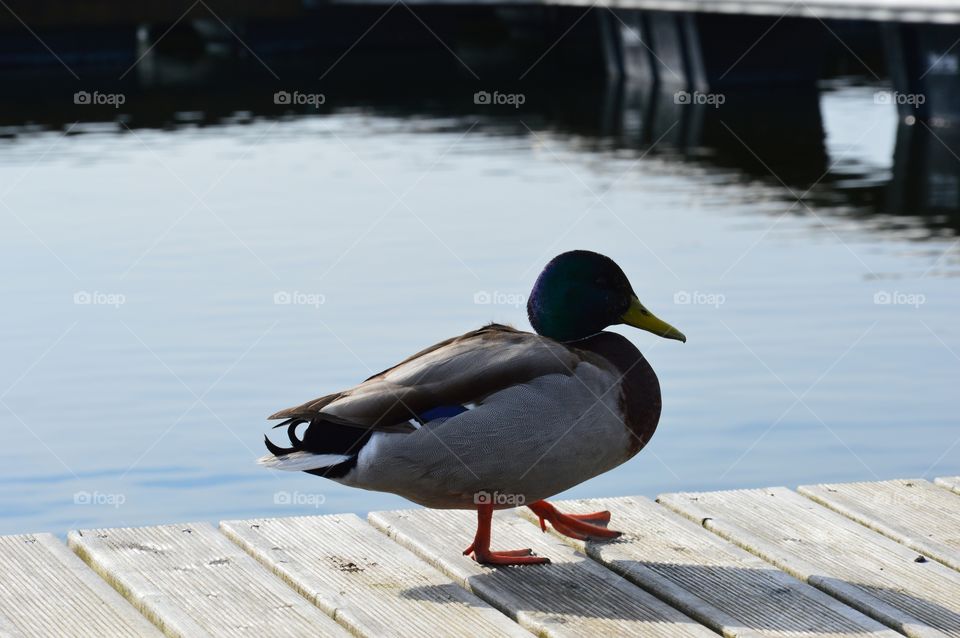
[{"x1": 527, "y1": 250, "x2": 687, "y2": 342}]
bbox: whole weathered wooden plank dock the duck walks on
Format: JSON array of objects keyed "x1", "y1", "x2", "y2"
[{"x1": 0, "y1": 477, "x2": 960, "y2": 638}]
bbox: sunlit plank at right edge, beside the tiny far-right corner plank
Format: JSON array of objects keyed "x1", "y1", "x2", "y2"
[{"x1": 797, "y1": 479, "x2": 960, "y2": 569}]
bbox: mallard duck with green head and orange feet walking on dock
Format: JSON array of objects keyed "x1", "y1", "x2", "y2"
[{"x1": 260, "y1": 250, "x2": 686, "y2": 565}]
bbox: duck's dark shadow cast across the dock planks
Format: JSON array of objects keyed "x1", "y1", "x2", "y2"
[{"x1": 401, "y1": 556, "x2": 960, "y2": 636}]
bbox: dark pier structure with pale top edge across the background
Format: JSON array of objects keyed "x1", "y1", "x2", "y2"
[{"x1": 0, "y1": 0, "x2": 960, "y2": 126}]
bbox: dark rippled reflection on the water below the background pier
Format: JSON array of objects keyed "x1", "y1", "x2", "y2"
[{"x1": 0, "y1": 35, "x2": 960, "y2": 238}]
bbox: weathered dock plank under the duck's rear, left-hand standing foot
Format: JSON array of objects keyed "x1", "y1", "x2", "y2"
[{"x1": 370, "y1": 510, "x2": 716, "y2": 638}]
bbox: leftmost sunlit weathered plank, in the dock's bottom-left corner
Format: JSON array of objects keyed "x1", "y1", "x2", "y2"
[{"x1": 0, "y1": 534, "x2": 161, "y2": 638}]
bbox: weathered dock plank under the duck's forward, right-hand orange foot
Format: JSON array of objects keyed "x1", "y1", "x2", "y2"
[{"x1": 522, "y1": 497, "x2": 900, "y2": 638}]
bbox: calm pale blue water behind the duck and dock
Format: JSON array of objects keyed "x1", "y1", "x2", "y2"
[{"x1": 0, "y1": 84, "x2": 960, "y2": 533}]
